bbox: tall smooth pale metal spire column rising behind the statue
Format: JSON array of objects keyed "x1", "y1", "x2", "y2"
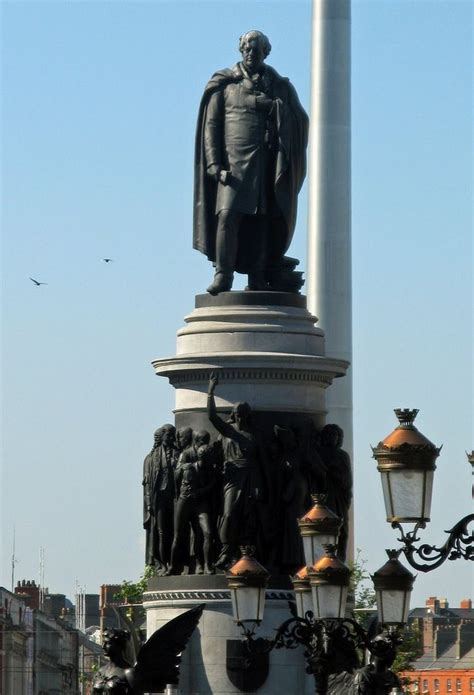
[{"x1": 307, "y1": 0, "x2": 352, "y2": 455}]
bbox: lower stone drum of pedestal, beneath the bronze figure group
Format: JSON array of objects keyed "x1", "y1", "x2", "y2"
[{"x1": 144, "y1": 575, "x2": 314, "y2": 695}]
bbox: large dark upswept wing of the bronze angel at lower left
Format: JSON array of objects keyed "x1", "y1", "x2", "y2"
[{"x1": 126, "y1": 604, "x2": 205, "y2": 695}]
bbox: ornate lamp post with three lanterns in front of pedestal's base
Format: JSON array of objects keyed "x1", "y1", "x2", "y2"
[{"x1": 227, "y1": 545, "x2": 414, "y2": 695}]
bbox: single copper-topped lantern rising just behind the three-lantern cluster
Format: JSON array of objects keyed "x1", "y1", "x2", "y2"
[{"x1": 298, "y1": 494, "x2": 342, "y2": 566}]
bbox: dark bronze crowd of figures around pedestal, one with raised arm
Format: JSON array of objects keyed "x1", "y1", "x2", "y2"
[{"x1": 143, "y1": 375, "x2": 352, "y2": 575}]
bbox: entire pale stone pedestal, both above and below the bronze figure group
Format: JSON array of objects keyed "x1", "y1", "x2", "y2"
[{"x1": 144, "y1": 292, "x2": 348, "y2": 695}]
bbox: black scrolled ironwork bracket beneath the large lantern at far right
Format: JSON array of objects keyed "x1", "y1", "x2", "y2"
[{"x1": 392, "y1": 514, "x2": 474, "y2": 572}]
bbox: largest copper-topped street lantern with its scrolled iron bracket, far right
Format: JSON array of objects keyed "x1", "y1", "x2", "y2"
[{"x1": 372, "y1": 409, "x2": 474, "y2": 572}]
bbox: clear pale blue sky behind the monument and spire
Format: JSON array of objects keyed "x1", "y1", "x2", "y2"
[{"x1": 0, "y1": 0, "x2": 474, "y2": 605}]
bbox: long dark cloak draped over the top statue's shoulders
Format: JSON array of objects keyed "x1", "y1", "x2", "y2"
[{"x1": 193, "y1": 63, "x2": 309, "y2": 273}]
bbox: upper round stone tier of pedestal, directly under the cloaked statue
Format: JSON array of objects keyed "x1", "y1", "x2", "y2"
[{"x1": 153, "y1": 292, "x2": 348, "y2": 430}]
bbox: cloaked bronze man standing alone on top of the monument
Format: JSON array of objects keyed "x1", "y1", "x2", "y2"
[{"x1": 193, "y1": 31, "x2": 308, "y2": 294}]
